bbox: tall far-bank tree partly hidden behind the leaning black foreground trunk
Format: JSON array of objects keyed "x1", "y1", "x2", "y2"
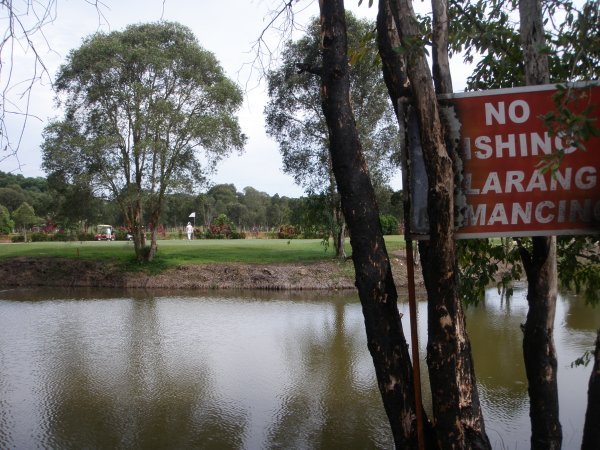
[{"x1": 265, "y1": 13, "x2": 399, "y2": 256}]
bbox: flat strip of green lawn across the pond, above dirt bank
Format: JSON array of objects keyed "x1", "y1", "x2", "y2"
[{"x1": 0, "y1": 236, "x2": 404, "y2": 269}]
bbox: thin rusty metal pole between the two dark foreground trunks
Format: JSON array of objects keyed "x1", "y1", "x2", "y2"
[{"x1": 404, "y1": 236, "x2": 425, "y2": 450}]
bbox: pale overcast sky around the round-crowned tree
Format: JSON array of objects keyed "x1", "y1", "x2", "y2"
[{"x1": 0, "y1": 0, "x2": 446, "y2": 197}]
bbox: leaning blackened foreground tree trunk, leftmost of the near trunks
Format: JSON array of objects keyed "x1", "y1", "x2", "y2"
[{"x1": 315, "y1": 0, "x2": 417, "y2": 448}]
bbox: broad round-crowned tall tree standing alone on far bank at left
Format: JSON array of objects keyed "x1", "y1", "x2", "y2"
[{"x1": 43, "y1": 22, "x2": 245, "y2": 260}]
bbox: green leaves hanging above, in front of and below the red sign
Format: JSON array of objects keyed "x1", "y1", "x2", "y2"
[{"x1": 450, "y1": 0, "x2": 600, "y2": 301}]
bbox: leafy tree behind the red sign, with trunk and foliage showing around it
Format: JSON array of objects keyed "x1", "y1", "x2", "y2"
[{"x1": 452, "y1": 1, "x2": 600, "y2": 448}]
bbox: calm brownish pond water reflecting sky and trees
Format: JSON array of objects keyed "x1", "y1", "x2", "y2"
[{"x1": 0, "y1": 289, "x2": 600, "y2": 449}]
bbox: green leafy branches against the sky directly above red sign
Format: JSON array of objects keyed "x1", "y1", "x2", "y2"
[{"x1": 450, "y1": 0, "x2": 600, "y2": 90}]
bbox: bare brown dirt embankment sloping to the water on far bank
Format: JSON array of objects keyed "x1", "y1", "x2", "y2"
[{"x1": 0, "y1": 254, "x2": 422, "y2": 290}]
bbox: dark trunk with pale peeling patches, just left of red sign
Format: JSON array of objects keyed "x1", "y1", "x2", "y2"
[{"x1": 390, "y1": 0, "x2": 490, "y2": 449}]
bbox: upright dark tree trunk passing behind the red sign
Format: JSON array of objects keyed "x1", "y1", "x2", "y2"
[{"x1": 519, "y1": 0, "x2": 562, "y2": 449}]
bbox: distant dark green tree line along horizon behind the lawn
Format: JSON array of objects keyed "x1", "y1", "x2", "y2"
[{"x1": 0, "y1": 171, "x2": 403, "y2": 238}]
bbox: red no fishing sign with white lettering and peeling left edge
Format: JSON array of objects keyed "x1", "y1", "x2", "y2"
[{"x1": 451, "y1": 85, "x2": 600, "y2": 238}]
